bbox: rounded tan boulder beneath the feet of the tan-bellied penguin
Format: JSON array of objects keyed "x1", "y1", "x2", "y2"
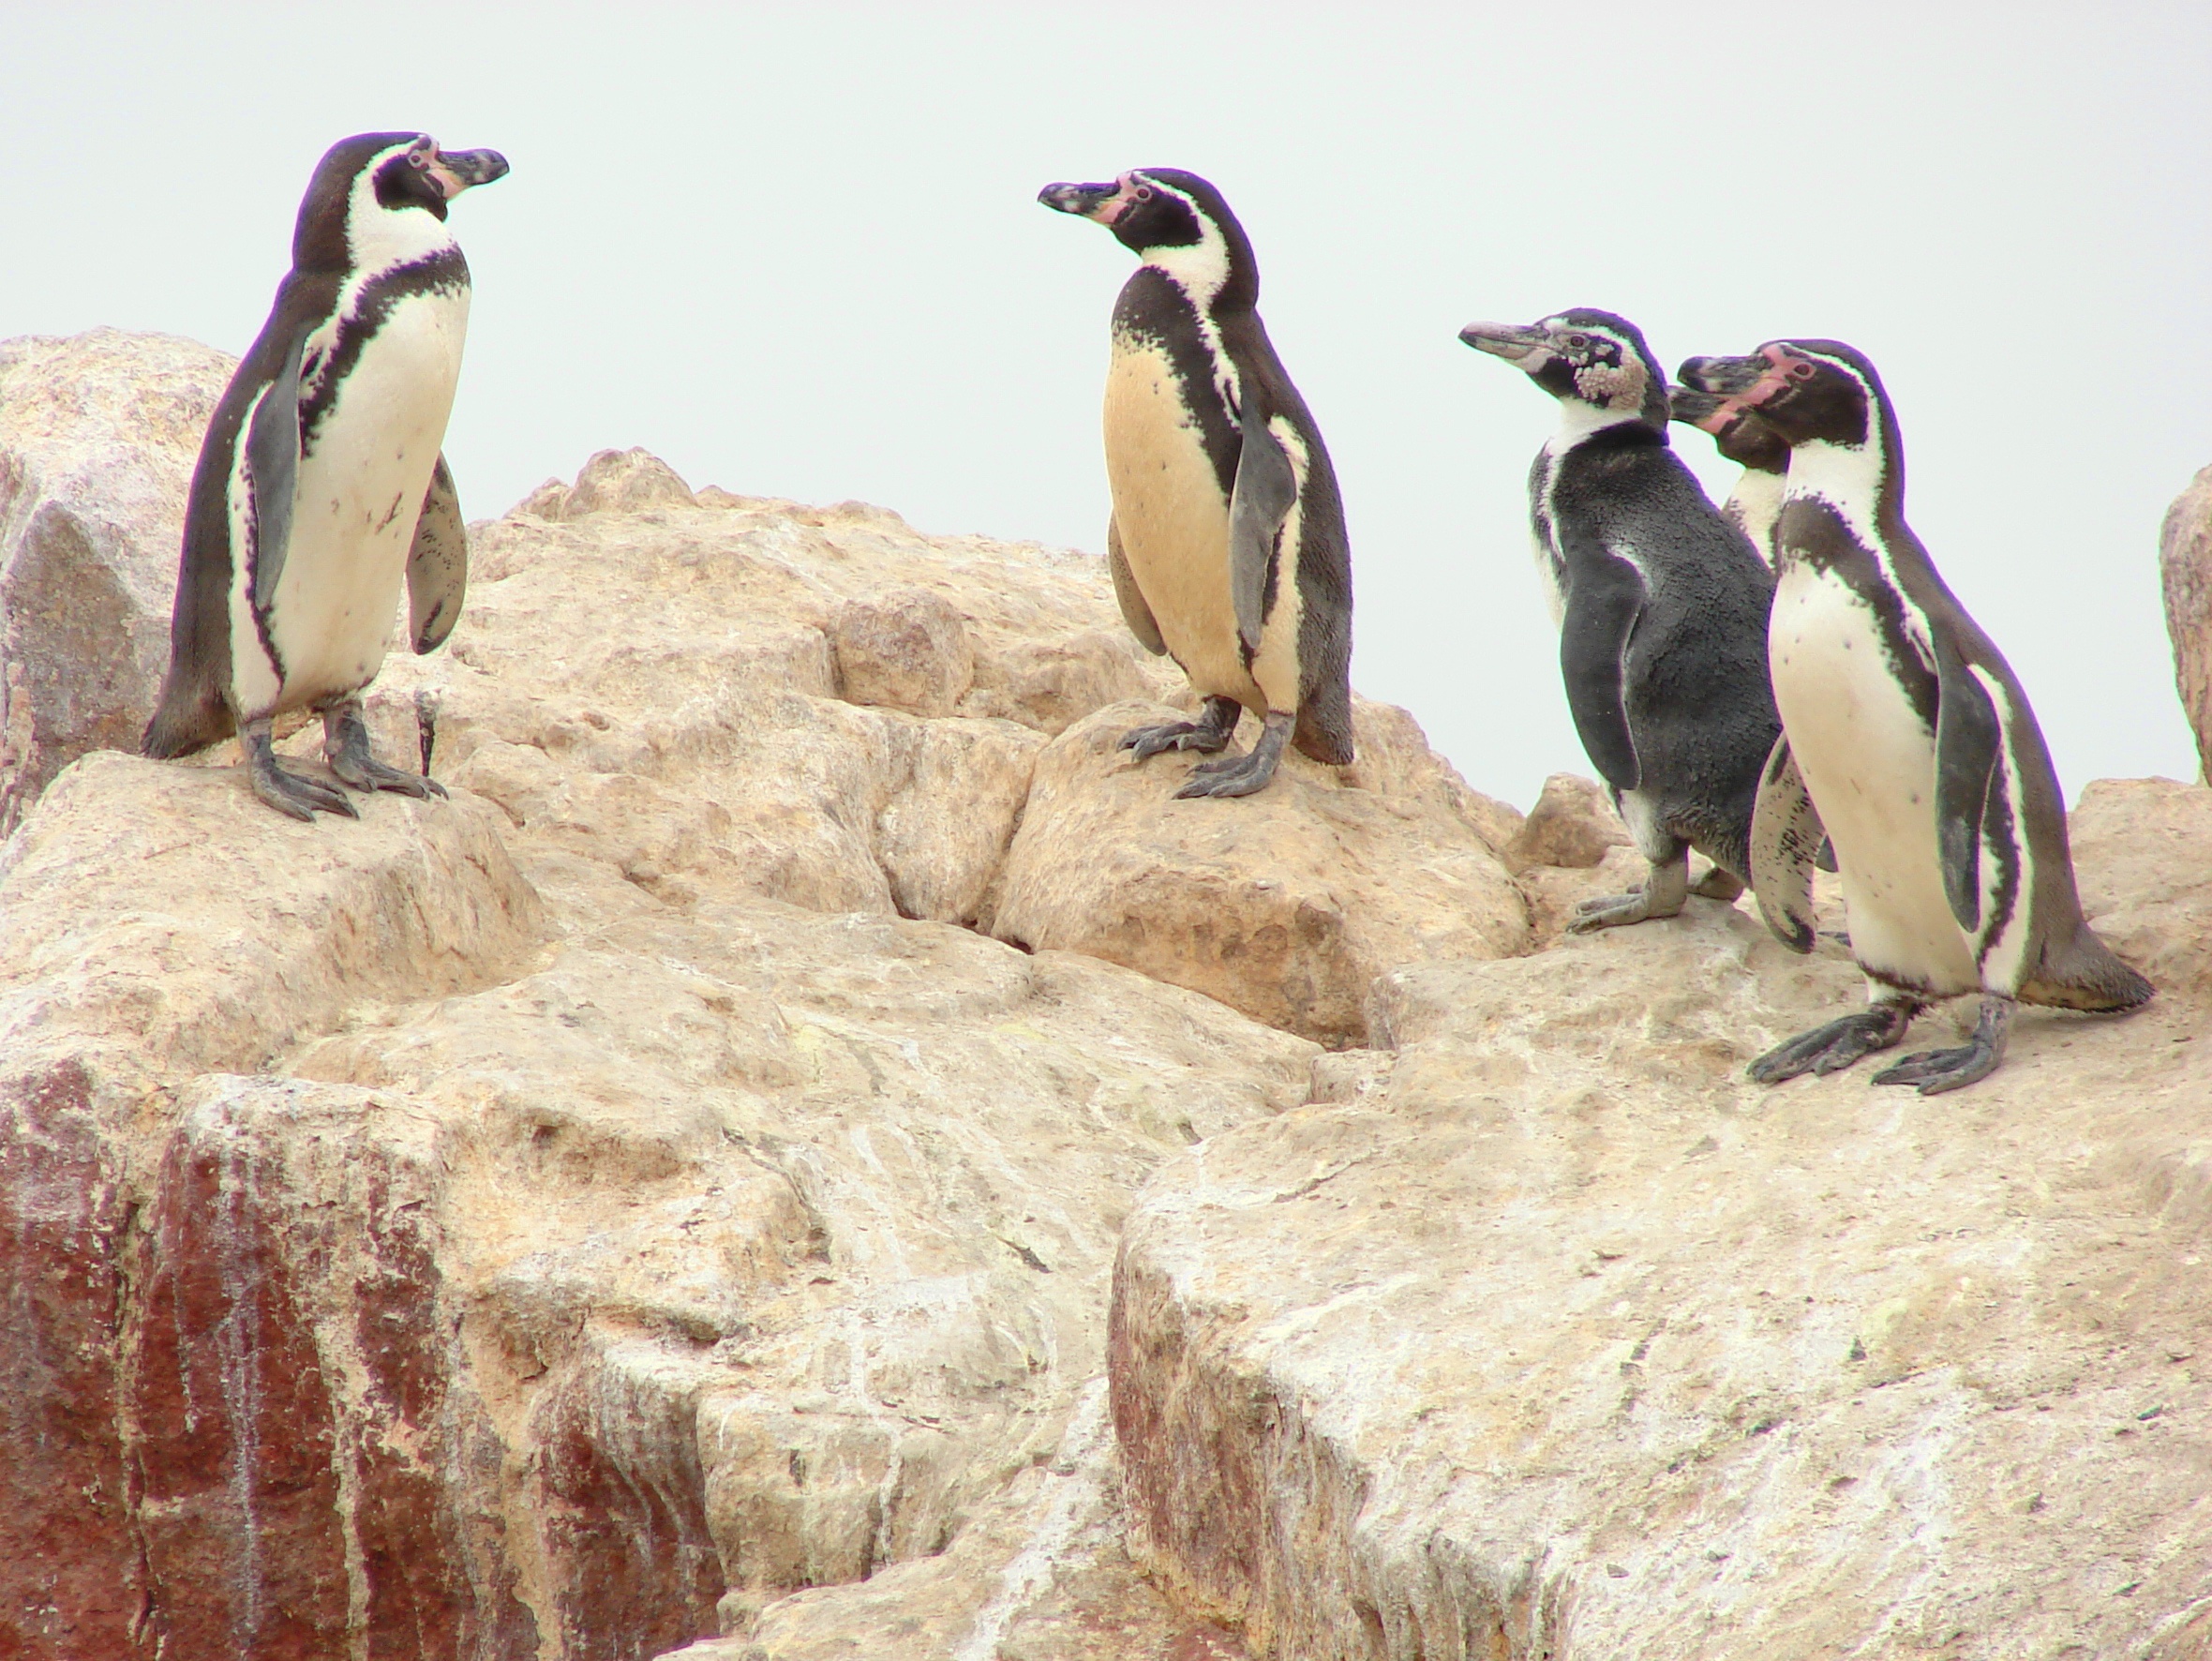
[{"x1": 991, "y1": 703, "x2": 1529, "y2": 1048}]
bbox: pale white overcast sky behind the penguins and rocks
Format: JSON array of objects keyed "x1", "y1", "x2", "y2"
[{"x1": 0, "y1": 0, "x2": 2212, "y2": 807}]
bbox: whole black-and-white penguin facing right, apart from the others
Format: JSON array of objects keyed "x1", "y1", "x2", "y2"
[{"x1": 140, "y1": 133, "x2": 506, "y2": 820}]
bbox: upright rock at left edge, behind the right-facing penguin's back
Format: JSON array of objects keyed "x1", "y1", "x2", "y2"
[{"x1": 0, "y1": 330, "x2": 234, "y2": 836}]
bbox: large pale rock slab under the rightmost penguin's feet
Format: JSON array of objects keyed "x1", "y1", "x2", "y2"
[{"x1": 1108, "y1": 781, "x2": 2212, "y2": 1661}]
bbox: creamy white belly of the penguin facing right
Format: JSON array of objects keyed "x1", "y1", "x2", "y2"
[{"x1": 232, "y1": 292, "x2": 469, "y2": 719}]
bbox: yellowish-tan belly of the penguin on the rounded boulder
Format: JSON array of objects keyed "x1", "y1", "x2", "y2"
[{"x1": 1106, "y1": 340, "x2": 1264, "y2": 710}]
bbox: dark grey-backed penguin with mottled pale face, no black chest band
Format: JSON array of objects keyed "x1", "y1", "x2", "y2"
[{"x1": 1460, "y1": 309, "x2": 1787, "y2": 931}]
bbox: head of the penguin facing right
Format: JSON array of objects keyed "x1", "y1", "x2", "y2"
[{"x1": 292, "y1": 133, "x2": 506, "y2": 270}]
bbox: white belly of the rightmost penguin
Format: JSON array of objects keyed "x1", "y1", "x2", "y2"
[{"x1": 1768, "y1": 561, "x2": 1982, "y2": 997}]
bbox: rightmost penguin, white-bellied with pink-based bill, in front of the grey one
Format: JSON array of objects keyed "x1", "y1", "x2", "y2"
[{"x1": 1681, "y1": 340, "x2": 2152, "y2": 1095}]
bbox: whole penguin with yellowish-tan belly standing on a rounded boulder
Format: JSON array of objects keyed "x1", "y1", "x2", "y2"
[{"x1": 1038, "y1": 168, "x2": 1352, "y2": 796}]
